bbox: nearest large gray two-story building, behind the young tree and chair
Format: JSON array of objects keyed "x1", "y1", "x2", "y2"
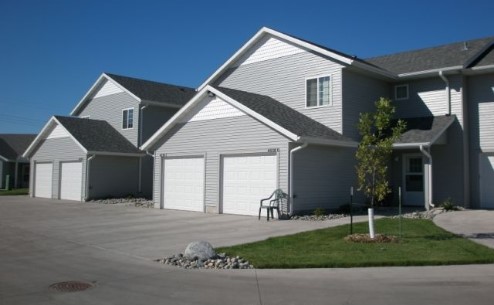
[{"x1": 141, "y1": 28, "x2": 494, "y2": 215}]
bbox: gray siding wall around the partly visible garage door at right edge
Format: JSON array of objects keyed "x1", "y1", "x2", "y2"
[{"x1": 467, "y1": 74, "x2": 494, "y2": 208}]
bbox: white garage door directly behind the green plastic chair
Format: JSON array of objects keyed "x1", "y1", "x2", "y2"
[{"x1": 222, "y1": 156, "x2": 277, "y2": 215}]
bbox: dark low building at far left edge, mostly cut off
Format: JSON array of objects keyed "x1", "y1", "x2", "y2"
[{"x1": 0, "y1": 134, "x2": 36, "y2": 189}]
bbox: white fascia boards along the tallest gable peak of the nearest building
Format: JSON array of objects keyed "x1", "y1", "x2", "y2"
[{"x1": 197, "y1": 27, "x2": 356, "y2": 91}]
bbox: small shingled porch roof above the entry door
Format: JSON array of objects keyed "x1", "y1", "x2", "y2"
[{"x1": 395, "y1": 115, "x2": 456, "y2": 144}]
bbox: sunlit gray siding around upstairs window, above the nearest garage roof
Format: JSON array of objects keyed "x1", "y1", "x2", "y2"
[{"x1": 215, "y1": 52, "x2": 343, "y2": 132}]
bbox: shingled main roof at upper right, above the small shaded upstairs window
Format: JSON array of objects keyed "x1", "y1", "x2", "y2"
[{"x1": 365, "y1": 37, "x2": 494, "y2": 74}]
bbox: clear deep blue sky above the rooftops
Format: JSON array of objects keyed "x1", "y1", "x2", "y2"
[{"x1": 0, "y1": 0, "x2": 494, "y2": 133}]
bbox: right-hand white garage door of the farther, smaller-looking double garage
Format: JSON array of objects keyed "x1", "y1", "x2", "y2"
[{"x1": 60, "y1": 162, "x2": 82, "y2": 201}]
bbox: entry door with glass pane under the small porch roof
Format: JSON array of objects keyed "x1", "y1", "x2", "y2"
[{"x1": 403, "y1": 154, "x2": 424, "y2": 206}]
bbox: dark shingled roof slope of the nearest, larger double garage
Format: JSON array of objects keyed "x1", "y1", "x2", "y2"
[{"x1": 216, "y1": 87, "x2": 353, "y2": 142}]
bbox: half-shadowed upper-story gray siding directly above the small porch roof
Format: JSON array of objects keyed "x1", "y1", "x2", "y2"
[{"x1": 391, "y1": 75, "x2": 463, "y2": 124}]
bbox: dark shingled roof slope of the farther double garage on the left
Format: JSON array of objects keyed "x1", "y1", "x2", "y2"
[{"x1": 55, "y1": 116, "x2": 143, "y2": 154}]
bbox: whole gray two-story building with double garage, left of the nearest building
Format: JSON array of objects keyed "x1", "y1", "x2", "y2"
[{"x1": 24, "y1": 73, "x2": 195, "y2": 201}]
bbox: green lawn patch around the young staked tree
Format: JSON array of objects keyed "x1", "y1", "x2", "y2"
[{"x1": 216, "y1": 218, "x2": 494, "y2": 268}]
